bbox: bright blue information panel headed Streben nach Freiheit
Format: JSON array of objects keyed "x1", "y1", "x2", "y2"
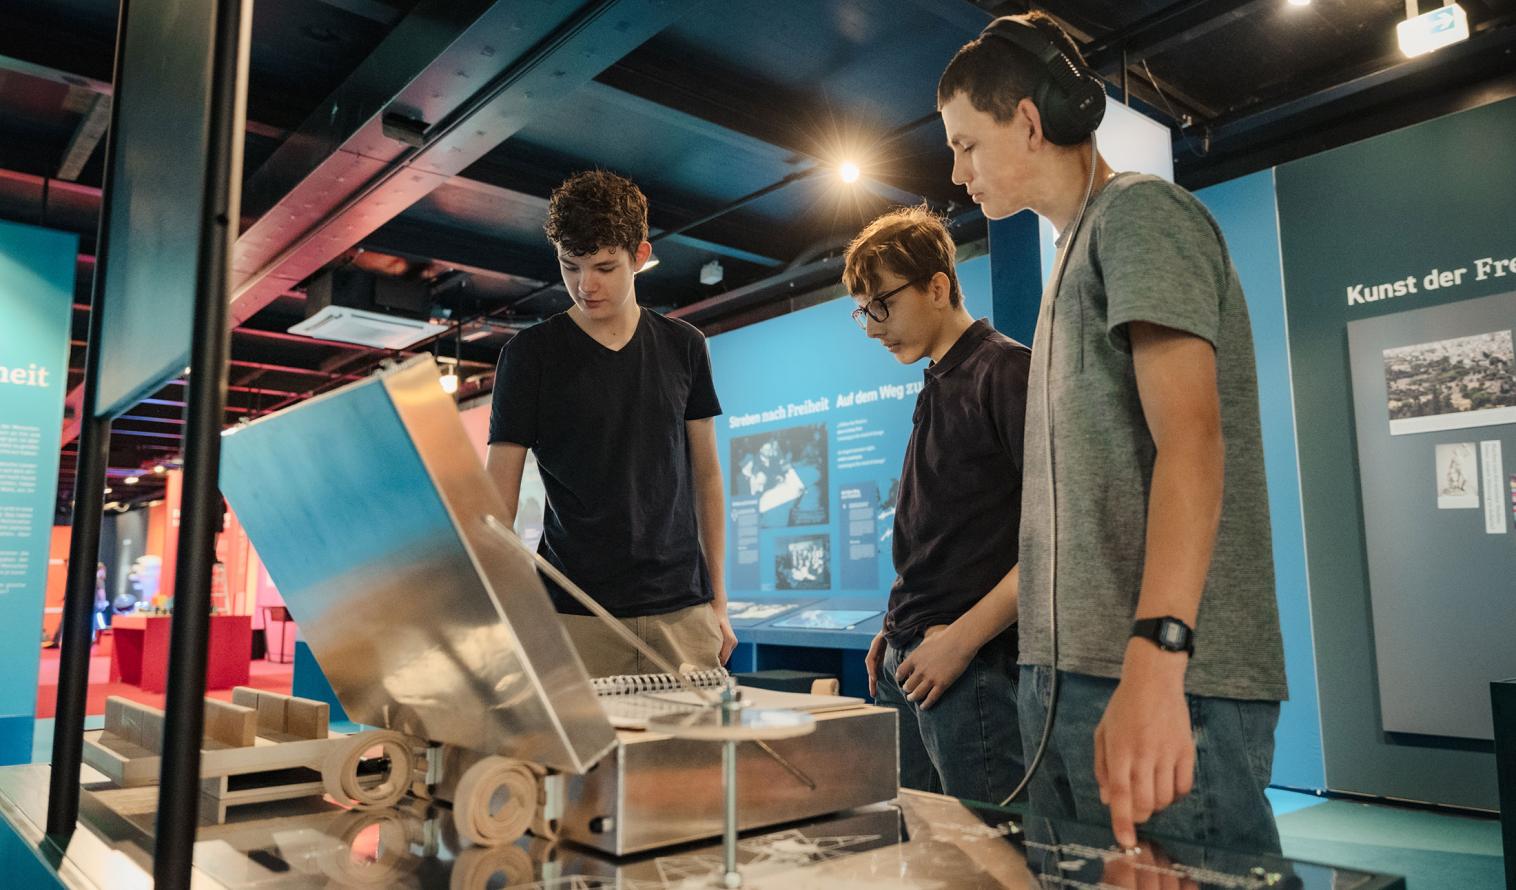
[{"x1": 709, "y1": 256, "x2": 991, "y2": 606}]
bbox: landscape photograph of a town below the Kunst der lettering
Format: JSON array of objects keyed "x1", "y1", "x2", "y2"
[{"x1": 1384, "y1": 331, "x2": 1516, "y2": 435}]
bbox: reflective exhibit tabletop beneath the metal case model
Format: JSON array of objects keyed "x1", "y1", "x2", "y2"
[{"x1": 0, "y1": 766, "x2": 1405, "y2": 890}]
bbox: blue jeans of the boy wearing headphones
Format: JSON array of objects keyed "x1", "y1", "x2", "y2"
[{"x1": 1019, "y1": 666, "x2": 1280, "y2": 854}]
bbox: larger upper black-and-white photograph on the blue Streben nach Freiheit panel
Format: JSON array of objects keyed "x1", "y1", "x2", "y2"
[{"x1": 732, "y1": 423, "x2": 829, "y2": 528}]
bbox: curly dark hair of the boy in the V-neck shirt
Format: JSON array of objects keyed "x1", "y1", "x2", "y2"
[{"x1": 543, "y1": 170, "x2": 647, "y2": 256}]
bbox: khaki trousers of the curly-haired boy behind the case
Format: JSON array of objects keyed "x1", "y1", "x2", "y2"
[{"x1": 558, "y1": 603, "x2": 722, "y2": 676}]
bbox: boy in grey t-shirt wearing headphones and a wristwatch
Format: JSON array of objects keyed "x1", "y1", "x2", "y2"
[{"x1": 937, "y1": 14, "x2": 1286, "y2": 852}]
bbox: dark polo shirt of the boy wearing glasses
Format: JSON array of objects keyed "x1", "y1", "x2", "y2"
[{"x1": 884, "y1": 318, "x2": 1031, "y2": 649}]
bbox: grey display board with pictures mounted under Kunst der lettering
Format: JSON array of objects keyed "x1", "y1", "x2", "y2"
[{"x1": 1348, "y1": 293, "x2": 1516, "y2": 740}]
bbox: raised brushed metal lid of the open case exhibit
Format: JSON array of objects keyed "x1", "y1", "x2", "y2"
[{"x1": 221, "y1": 356, "x2": 615, "y2": 773}]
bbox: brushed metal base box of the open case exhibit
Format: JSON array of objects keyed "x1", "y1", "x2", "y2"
[{"x1": 558, "y1": 705, "x2": 899, "y2": 855}]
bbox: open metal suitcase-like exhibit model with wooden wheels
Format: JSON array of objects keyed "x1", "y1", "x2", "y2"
[{"x1": 213, "y1": 356, "x2": 897, "y2": 873}]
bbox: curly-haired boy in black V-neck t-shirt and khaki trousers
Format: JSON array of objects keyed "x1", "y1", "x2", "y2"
[{"x1": 487, "y1": 170, "x2": 737, "y2": 676}]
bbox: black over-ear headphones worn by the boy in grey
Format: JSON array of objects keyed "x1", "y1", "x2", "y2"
[{"x1": 979, "y1": 15, "x2": 1105, "y2": 146}]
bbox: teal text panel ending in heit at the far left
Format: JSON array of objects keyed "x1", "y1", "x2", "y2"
[{"x1": 0, "y1": 221, "x2": 79, "y2": 764}]
